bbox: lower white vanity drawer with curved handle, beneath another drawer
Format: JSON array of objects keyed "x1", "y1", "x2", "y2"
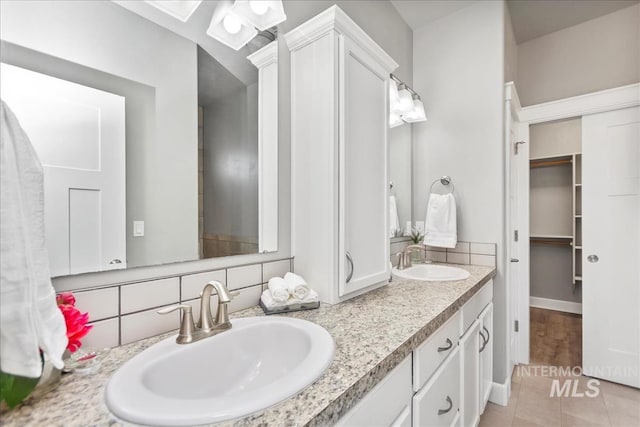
[{"x1": 413, "y1": 347, "x2": 460, "y2": 427}]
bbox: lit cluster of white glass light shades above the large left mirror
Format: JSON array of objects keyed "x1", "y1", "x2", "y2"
[{"x1": 207, "y1": 0, "x2": 287, "y2": 50}]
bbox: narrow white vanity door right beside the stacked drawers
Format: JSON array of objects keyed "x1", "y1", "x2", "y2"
[{"x1": 460, "y1": 319, "x2": 482, "y2": 427}]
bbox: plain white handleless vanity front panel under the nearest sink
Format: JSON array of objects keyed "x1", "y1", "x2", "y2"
[{"x1": 335, "y1": 356, "x2": 413, "y2": 427}]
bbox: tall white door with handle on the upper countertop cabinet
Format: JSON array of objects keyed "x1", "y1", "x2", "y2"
[{"x1": 339, "y1": 36, "x2": 390, "y2": 296}]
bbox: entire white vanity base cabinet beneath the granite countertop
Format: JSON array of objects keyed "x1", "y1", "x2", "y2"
[{"x1": 337, "y1": 280, "x2": 493, "y2": 427}]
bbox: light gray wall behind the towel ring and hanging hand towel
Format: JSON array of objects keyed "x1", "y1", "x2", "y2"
[{"x1": 413, "y1": 1, "x2": 507, "y2": 382}]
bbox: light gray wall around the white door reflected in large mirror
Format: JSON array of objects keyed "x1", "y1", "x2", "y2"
[{"x1": 0, "y1": 1, "x2": 198, "y2": 266}]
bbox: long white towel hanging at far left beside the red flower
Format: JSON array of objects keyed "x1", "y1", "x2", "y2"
[{"x1": 0, "y1": 100, "x2": 67, "y2": 378}]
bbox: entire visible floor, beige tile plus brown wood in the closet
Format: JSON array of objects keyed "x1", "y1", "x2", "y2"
[{"x1": 480, "y1": 308, "x2": 640, "y2": 427}]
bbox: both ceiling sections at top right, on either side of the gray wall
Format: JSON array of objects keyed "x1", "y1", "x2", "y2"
[{"x1": 391, "y1": 0, "x2": 640, "y2": 43}]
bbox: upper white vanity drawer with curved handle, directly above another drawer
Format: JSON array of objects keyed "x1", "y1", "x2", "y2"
[{"x1": 413, "y1": 311, "x2": 461, "y2": 391}]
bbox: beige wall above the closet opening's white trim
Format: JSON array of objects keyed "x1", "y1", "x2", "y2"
[{"x1": 516, "y1": 5, "x2": 640, "y2": 106}]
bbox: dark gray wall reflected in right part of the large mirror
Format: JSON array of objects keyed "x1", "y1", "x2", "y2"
[{"x1": 203, "y1": 84, "x2": 258, "y2": 237}]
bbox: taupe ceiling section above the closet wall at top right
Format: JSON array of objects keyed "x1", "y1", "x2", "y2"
[{"x1": 507, "y1": 0, "x2": 640, "y2": 44}]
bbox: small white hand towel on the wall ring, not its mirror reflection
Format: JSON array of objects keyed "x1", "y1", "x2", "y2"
[{"x1": 424, "y1": 193, "x2": 458, "y2": 248}]
